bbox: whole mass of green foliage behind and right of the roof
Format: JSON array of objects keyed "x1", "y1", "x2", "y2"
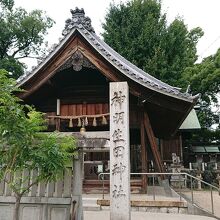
[{"x1": 103, "y1": 0, "x2": 220, "y2": 127}]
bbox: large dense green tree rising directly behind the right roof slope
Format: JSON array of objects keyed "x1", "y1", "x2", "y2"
[{"x1": 103, "y1": 0, "x2": 203, "y2": 88}]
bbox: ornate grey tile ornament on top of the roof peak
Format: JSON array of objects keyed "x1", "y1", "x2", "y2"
[{"x1": 62, "y1": 7, "x2": 95, "y2": 36}]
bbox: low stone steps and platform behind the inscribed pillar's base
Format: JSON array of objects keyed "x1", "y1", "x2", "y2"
[{"x1": 83, "y1": 186, "x2": 187, "y2": 213}]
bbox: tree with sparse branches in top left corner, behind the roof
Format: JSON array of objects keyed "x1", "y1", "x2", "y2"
[{"x1": 0, "y1": 0, "x2": 54, "y2": 78}]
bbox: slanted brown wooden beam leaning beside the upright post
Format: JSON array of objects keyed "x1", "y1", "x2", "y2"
[{"x1": 143, "y1": 112, "x2": 164, "y2": 173}]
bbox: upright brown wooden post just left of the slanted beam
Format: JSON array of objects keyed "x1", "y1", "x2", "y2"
[{"x1": 141, "y1": 110, "x2": 147, "y2": 193}]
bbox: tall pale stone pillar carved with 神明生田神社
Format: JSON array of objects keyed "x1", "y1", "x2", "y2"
[{"x1": 110, "y1": 82, "x2": 131, "y2": 220}]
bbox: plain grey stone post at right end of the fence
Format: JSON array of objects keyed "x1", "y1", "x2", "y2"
[{"x1": 72, "y1": 151, "x2": 83, "y2": 220}]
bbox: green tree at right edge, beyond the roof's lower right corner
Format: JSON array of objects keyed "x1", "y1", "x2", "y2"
[{"x1": 183, "y1": 49, "x2": 220, "y2": 127}]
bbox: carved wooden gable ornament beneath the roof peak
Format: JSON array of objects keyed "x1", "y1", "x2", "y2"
[{"x1": 57, "y1": 51, "x2": 96, "y2": 72}]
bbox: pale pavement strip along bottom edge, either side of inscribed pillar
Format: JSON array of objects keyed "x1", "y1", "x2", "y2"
[{"x1": 84, "y1": 211, "x2": 216, "y2": 220}]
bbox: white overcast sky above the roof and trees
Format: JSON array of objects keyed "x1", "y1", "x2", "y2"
[{"x1": 15, "y1": 0, "x2": 220, "y2": 65}]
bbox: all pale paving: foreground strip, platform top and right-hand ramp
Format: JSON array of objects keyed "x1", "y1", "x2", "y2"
[{"x1": 83, "y1": 188, "x2": 220, "y2": 220}]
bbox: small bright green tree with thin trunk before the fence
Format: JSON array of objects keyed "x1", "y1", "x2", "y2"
[{"x1": 0, "y1": 70, "x2": 76, "y2": 220}]
